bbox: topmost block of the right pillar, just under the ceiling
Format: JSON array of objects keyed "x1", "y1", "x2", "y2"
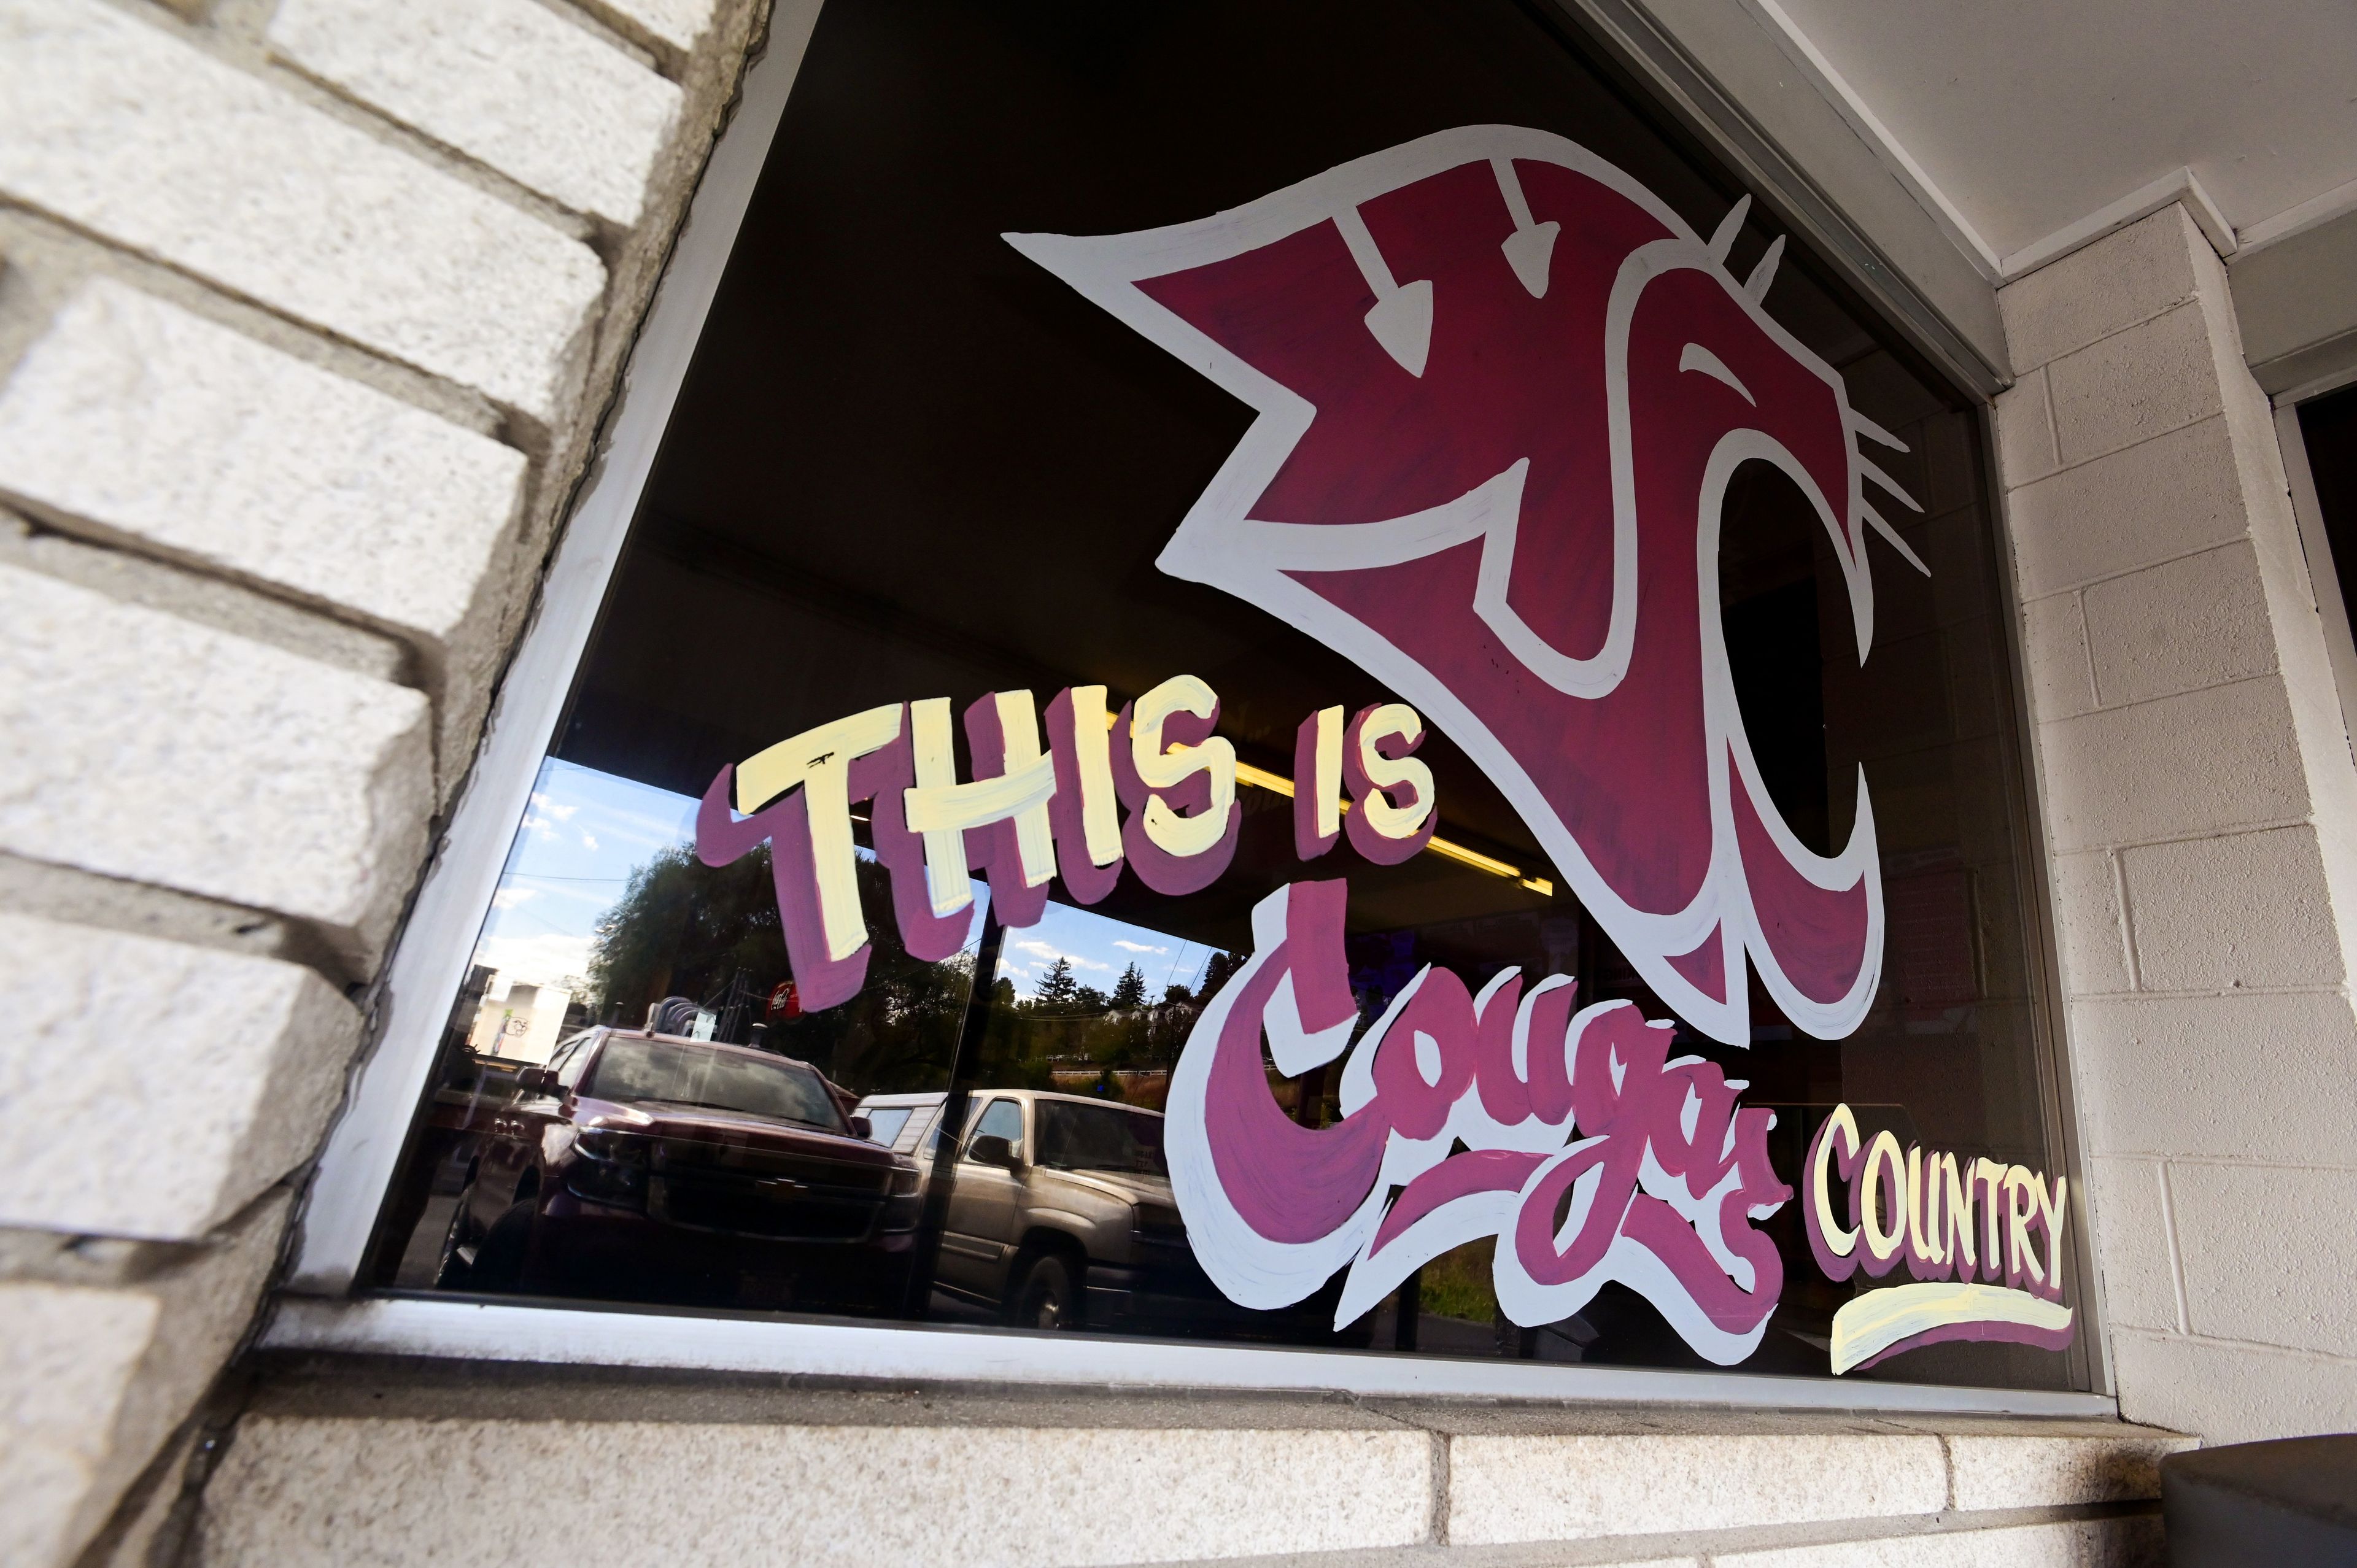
[{"x1": 1996, "y1": 207, "x2": 2208, "y2": 375}]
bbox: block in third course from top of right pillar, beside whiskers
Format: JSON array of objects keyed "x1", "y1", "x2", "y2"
[{"x1": 2006, "y1": 417, "x2": 2251, "y2": 599}]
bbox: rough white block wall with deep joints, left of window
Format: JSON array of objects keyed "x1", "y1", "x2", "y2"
[{"x1": 0, "y1": 0, "x2": 768, "y2": 1566}]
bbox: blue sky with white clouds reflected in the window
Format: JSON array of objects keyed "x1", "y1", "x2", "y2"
[{"x1": 476, "y1": 759, "x2": 1212, "y2": 1000}]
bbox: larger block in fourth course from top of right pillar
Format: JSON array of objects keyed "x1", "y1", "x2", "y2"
[{"x1": 2086, "y1": 540, "x2": 2275, "y2": 708}]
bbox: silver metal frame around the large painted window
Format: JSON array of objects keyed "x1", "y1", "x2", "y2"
[{"x1": 285, "y1": 0, "x2": 2116, "y2": 1417}]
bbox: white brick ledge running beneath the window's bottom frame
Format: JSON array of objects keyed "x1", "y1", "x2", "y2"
[{"x1": 198, "y1": 1405, "x2": 2185, "y2": 1568}]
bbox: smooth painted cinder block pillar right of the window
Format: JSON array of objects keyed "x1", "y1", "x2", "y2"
[{"x1": 1999, "y1": 207, "x2": 2357, "y2": 1441}]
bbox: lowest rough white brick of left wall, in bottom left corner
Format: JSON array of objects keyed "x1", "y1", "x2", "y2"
[{"x1": 0, "y1": 1195, "x2": 287, "y2": 1568}]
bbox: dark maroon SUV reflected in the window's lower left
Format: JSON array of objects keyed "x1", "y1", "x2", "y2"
[{"x1": 436, "y1": 1028, "x2": 921, "y2": 1311}]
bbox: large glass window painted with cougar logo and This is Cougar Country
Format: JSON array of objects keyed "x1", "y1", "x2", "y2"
[{"x1": 354, "y1": 0, "x2": 2084, "y2": 1389}]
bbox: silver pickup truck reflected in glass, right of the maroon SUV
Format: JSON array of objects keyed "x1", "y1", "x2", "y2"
[{"x1": 861, "y1": 1089, "x2": 1364, "y2": 1344}]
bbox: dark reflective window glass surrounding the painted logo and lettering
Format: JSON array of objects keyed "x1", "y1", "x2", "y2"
[{"x1": 370, "y1": 0, "x2": 2076, "y2": 1386}]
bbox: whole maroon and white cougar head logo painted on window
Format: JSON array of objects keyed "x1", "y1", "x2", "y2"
[{"x1": 1007, "y1": 125, "x2": 1923, "y2": 1045}]
